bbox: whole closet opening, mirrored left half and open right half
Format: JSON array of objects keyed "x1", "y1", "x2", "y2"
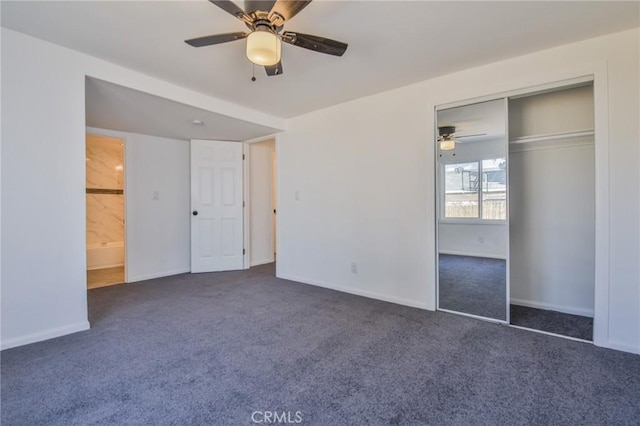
[{"x1": 435, "y1": 81, "x2": 596, "y2": 340}]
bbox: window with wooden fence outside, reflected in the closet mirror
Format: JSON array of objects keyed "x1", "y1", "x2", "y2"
[{"x1": 443, "y1": 158, "x2": 507, "y2": 220}]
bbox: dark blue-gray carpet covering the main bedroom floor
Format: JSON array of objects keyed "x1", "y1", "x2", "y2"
[{"x1": 1, "y1": 265, "x2": 640, "y2": 426}]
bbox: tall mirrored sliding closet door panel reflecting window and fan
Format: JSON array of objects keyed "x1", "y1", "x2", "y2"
[{"x1": 437, "y1": 99, "x2": 508, "y2": 321}]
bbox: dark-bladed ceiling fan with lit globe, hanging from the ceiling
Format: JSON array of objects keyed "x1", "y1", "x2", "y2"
[{"x1": 185, "y1": 0, "x2": 348, "y2": 75}]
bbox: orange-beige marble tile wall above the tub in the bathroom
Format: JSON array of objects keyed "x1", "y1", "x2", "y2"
[{"x1": 86, "y1": 135, "x2": 124, "y2": 245}]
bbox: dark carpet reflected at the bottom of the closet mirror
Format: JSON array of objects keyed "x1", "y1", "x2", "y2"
[{"x1": 438, "y1": 254, "x2": 507, "y2": 321}]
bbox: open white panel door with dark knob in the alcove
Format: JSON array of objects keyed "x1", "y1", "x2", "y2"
[{"x1": 191, "y1": 139, "x2": 244, "y2": 272}]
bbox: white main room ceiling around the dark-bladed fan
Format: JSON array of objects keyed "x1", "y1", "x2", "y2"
[{"x1": 1, "y1": 0, "x2": 640, "y2": 139}]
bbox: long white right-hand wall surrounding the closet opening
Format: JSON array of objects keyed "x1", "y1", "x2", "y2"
[{"x1": 277, "y1": 29, "x2": 640, "y2": 352}]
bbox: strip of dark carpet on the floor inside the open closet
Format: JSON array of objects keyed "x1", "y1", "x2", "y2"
[{"x1": 511, "y1": 305, "x2": 593, "y2": 340}]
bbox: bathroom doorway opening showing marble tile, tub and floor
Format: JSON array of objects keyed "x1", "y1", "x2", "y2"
[{"x1": 86, "y1": 134, "x2": 126, "y2": 289}]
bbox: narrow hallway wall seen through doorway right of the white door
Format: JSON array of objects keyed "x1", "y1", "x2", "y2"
[{"x1": 249, "y1": 139, "x2": 275, "y2": 266}]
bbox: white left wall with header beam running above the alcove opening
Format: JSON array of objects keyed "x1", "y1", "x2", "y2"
[{"x1": 1, "y1": 28, "x2": 284, "y2": 348}]
